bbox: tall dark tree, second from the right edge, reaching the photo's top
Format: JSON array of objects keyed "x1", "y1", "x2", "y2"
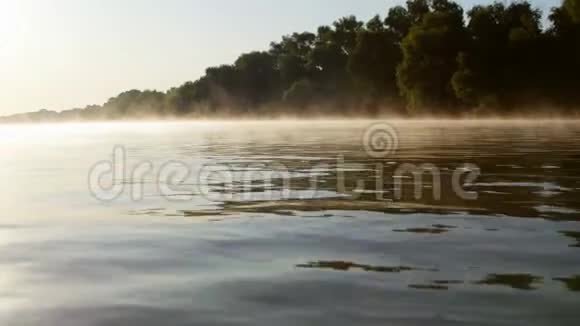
[{"x1": 452, "y1": 2, "x2": 547, "y2": 111}]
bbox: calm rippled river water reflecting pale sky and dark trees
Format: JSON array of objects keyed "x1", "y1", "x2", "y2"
[{"x1": 0, "y1": 121, "x2": 580, "y2": 326}]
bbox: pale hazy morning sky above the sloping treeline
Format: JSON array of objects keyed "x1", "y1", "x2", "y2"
[{"x1": 0, "y1": 0, "x2": 559, "y2": 115}]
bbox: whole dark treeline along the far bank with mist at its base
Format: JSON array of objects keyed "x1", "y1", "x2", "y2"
[{"x1": 3, "y1": 0, "x2": 580, "y2": 121}]
